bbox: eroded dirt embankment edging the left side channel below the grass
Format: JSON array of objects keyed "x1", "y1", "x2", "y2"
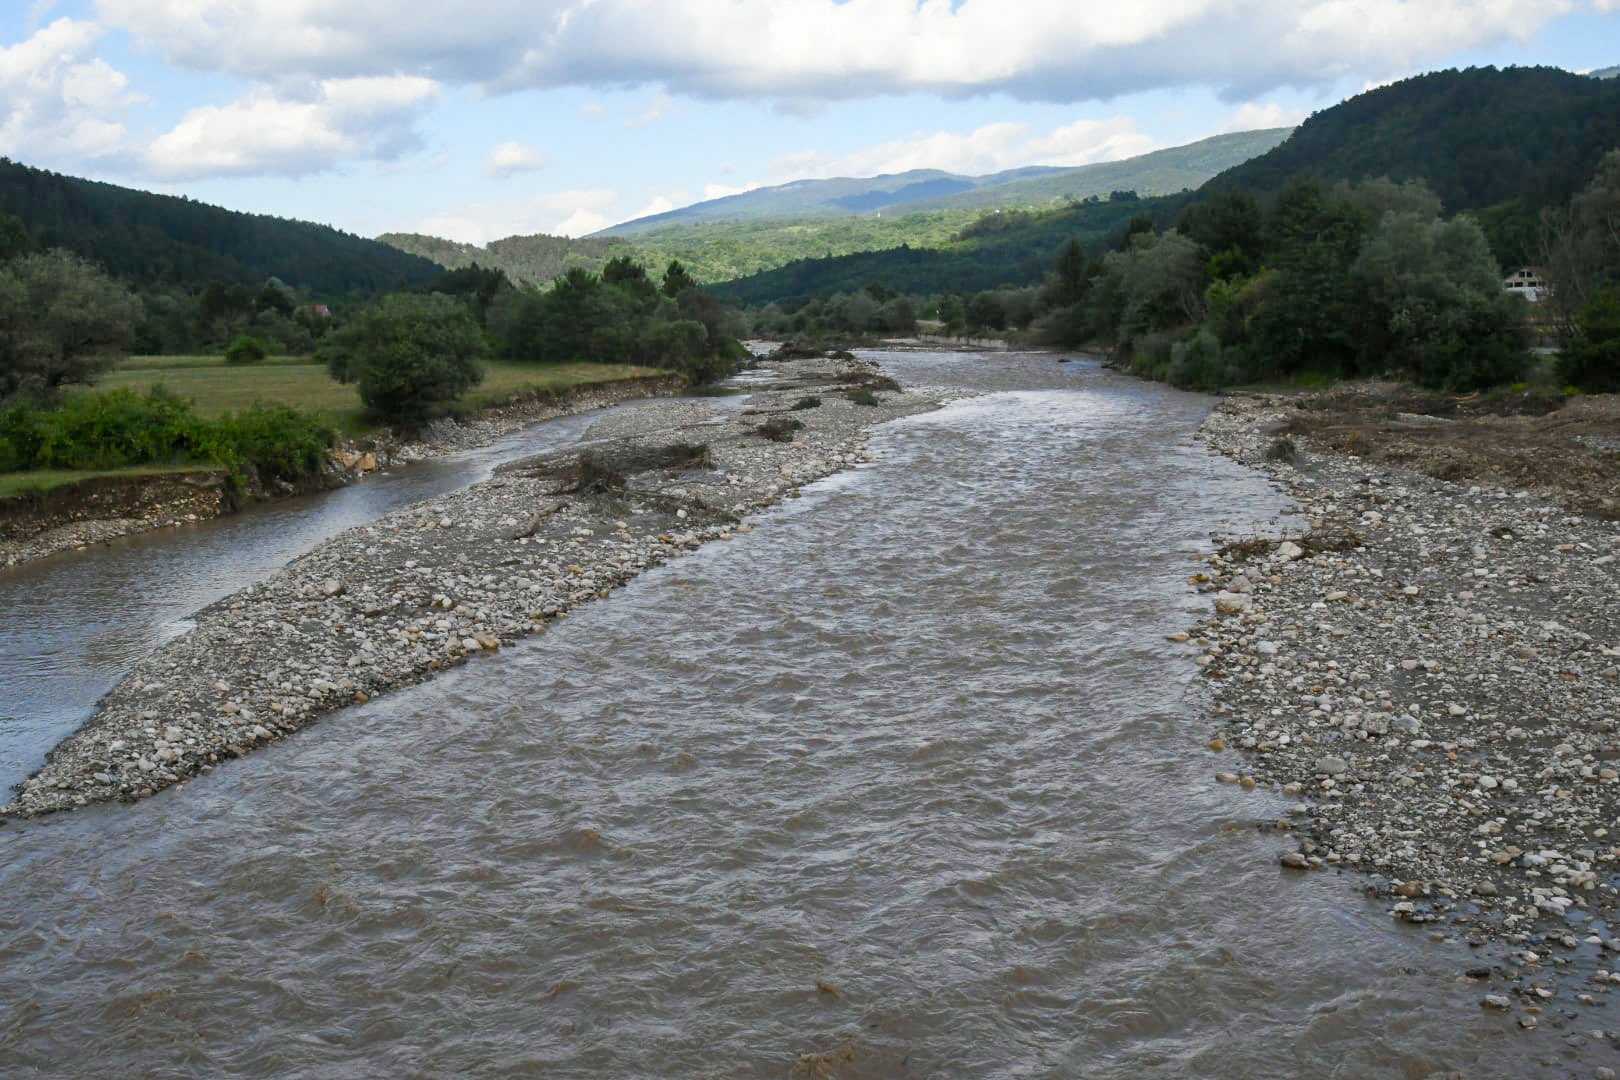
[{"x1": 0, "y1": 376, "x2": 687, "y2": 567}]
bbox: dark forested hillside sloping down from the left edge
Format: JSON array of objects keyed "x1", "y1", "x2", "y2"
[{"x1": 0, "y1": 159, "x2": 439, "y2": 296}]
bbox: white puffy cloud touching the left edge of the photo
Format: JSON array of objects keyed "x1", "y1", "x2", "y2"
[{"x1": 0, "y1": 19, "x2": 139, "y2": 165}]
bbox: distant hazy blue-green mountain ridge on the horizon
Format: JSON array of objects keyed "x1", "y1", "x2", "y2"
[{"x1": 593, "y1": 128, "x2": 1291, "y2": 238}]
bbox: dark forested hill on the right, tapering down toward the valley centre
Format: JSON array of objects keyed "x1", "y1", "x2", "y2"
[{"x1": 716, "y1": 68, "x2": 1620, "y2": 304}]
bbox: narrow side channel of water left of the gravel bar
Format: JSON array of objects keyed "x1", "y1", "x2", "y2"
[{"x1": 0, "y1": 393, "x2": 703, "y2": 790}]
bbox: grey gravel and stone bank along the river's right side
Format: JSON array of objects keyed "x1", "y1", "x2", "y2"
[{"x1": 1175, "y1": 397, "x2": 1620, "y2": 1027}]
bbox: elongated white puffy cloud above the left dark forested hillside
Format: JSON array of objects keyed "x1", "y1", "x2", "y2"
[{"x1": 146, "y1": 74, "x2": 437, "y2": 180}]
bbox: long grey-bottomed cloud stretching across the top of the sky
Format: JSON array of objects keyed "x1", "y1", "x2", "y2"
[{"x1": 96, "y1": 0, "x2": 1574, "y2": 105}]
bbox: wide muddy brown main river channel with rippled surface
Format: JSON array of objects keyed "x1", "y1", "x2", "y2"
[{"x1": 0, "y1": 355, "x2": 1555, "y2": 1078}]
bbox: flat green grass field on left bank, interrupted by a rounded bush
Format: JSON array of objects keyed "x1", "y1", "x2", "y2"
[{"x1": 96, "y1": 356, "x2": 659, "y2": 434}]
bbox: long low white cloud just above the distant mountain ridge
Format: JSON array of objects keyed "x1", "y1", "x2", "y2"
[{"x1": 771, "y1": 117, "x2": 1155, "y2": 180}]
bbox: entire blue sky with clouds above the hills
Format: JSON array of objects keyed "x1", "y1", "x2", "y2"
[{"x1": 0, "y1": 0, "x2": 1620, "y2": 243}]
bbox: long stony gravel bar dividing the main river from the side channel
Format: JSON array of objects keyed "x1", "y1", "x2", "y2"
[{"x1": 0, "y1": 359, "x2": 946, "y2": 816}]
